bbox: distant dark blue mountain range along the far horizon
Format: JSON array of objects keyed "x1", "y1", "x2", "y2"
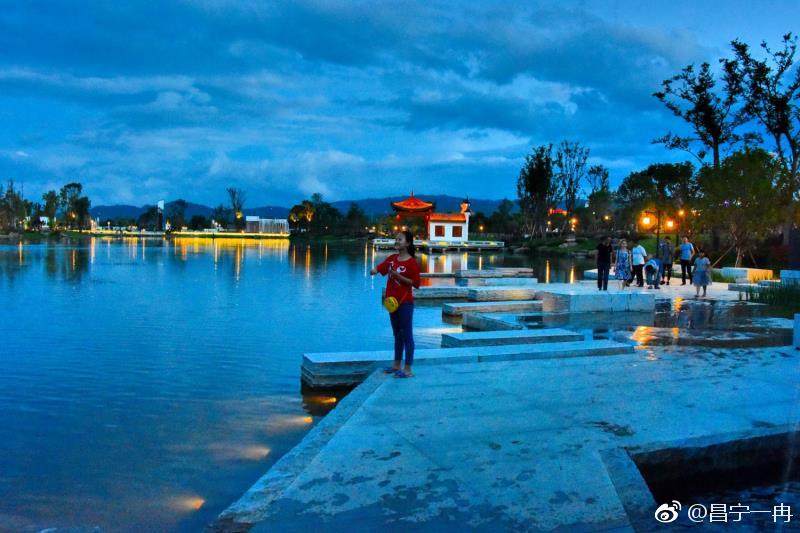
[{"x1": 90, "y1": 194, "x2": 516, "y2": 220}]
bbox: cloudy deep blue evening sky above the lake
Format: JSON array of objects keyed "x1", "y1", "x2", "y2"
[{"x1": 0, "y1": 0, "x2": 800, "y2": 207}]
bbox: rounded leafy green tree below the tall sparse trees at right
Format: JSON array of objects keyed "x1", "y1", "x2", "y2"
[{"x1": 698, "y1": 149, "x2": 782, "y2": 267}]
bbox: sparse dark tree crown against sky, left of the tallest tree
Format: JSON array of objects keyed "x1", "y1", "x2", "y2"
[{"x1": 653, "y1": 63, "x2": 753, "y2": 168}]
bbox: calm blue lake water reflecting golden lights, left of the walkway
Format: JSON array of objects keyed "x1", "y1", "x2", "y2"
[{"x1": 0, "y1": 238, "x2": 592, "y2": 531}]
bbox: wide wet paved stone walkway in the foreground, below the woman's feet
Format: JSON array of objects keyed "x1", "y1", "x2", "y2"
[{"x1": 233, "y1": 347, "x2": 800, "y2": 533}]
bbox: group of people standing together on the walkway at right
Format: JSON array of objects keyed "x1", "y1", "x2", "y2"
[{"x1": 597, "y1": 236, "x2": 711, "y2": 297}]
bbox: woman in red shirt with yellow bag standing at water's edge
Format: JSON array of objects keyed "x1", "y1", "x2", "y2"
[{"x1": 371, "y1": 231, "x2": 419, "y2": 378}]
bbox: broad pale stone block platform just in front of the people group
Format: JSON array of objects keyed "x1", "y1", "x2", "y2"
[{"x1": 536, "y1": 283, "x2": 656, "y2": 313}]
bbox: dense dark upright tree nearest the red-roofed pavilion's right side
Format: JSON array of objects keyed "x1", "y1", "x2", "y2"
[{"x1": 517, "y1": 144, "x2": 561, "y2": 236}]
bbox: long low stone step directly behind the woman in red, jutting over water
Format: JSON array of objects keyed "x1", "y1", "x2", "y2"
[{"x1": 301, "y1": 340, "x2": 634, "y2": 388}]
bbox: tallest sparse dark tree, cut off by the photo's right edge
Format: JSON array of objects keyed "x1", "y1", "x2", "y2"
[{"x1": 722, "y1": 33, "x2": 800, "y2": 244}]
